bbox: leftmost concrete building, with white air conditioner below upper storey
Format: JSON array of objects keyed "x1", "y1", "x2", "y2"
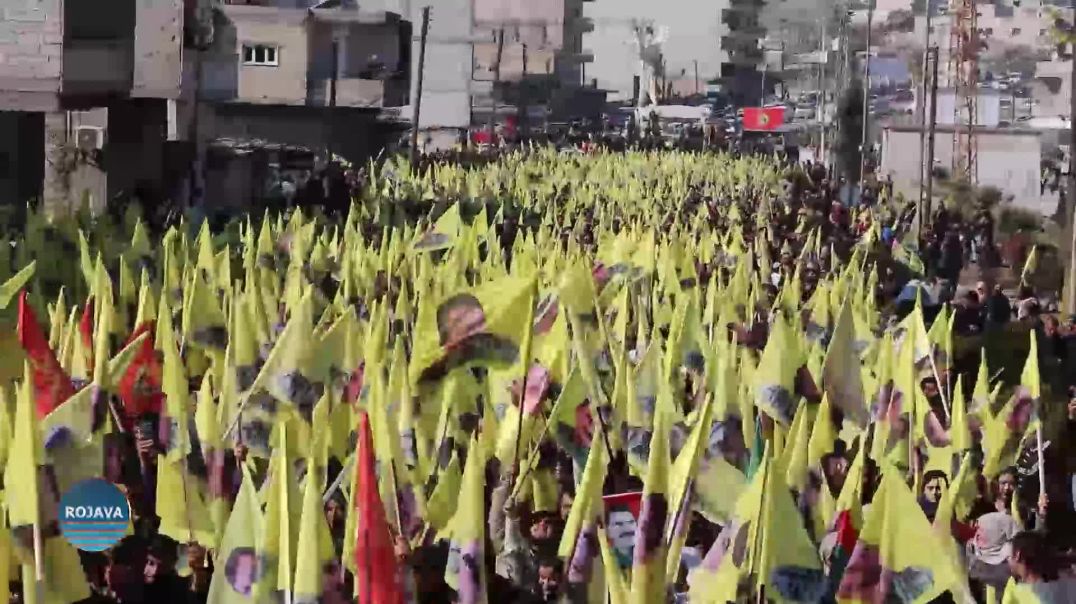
[{"x1": 0, "y1": 0, "x2": 185, "y2": 209}]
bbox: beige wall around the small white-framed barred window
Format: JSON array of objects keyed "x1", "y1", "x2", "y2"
[{"x1": 221, "y1": 5, "x2": 309, "y2": 104}]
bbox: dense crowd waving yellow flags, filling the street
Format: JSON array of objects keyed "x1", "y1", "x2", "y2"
[{"x1": 0, "y1": 150, "x2": 1076, "y2": 604}]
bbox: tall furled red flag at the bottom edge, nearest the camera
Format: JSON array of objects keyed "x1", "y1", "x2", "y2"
[{"x1": 352, "y1": 412, "x2": 404, "y2": 604}]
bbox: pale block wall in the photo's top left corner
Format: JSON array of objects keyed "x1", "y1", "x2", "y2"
[{"x1": 0, "y1": 0, "x2": 63, "y2": 111}]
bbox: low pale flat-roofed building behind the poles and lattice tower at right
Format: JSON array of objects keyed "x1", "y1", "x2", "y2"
[{"x1": 880, "y1": 126, "x2": 1057, "y2": 214}]
